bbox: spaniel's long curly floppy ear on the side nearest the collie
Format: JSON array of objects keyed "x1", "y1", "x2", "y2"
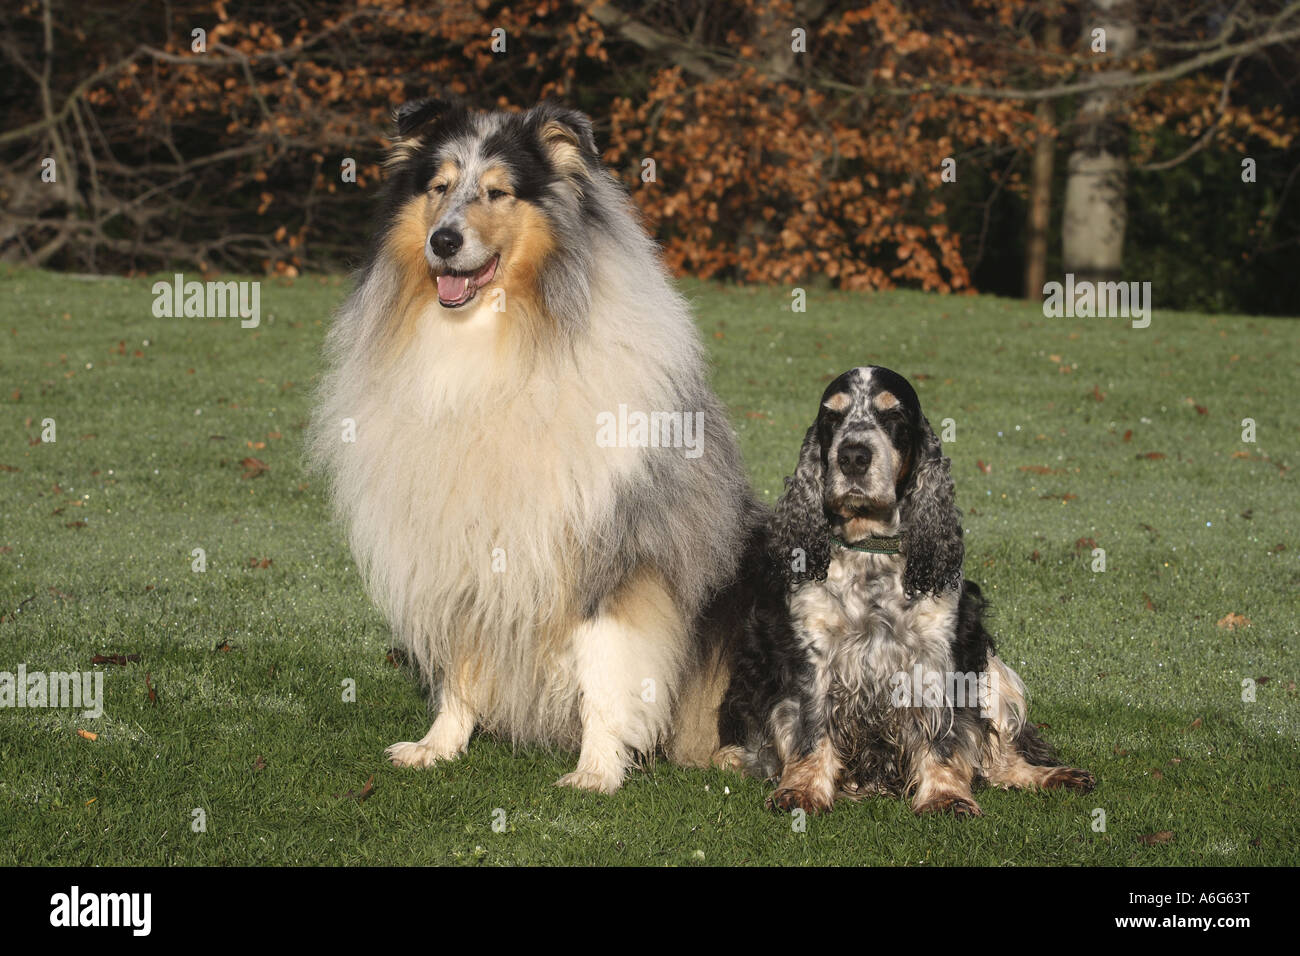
[{"x1": 770, "y1": 423, "x2": 831, "y2": 588}]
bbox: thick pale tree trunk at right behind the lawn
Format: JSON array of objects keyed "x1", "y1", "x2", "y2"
[{"x1": 1060, "y1": 0, "x2": 1138, "y2": 282}]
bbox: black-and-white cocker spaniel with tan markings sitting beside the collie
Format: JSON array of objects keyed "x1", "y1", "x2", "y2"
[{"x1": 716, "y1": 365, "x2": 1093, "y2": 816}]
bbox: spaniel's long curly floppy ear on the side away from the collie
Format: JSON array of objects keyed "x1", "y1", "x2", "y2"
[{"x1": 900, "y1": 418, "x2": 966, "y2": 594}]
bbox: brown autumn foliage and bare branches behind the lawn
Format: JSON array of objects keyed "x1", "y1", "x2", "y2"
[{"x1": 0, "y1": 0, "x2": 1294, "y2": 291}]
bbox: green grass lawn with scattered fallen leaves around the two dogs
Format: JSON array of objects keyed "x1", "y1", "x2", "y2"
[{"x1": 0, "y1": 272, "x2": 1300, "y2": 865}]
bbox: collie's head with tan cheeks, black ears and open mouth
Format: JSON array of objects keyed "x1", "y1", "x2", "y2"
[{"x1": 377, "y1": 99, "x2": 618, "y2": 330}]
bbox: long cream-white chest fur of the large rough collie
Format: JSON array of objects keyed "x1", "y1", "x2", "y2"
[{"x1": 316, "y1": 261, "x2": 717, "y2": 741}]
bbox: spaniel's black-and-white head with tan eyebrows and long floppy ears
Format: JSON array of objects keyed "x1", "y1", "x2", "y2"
[{"x1": 774, "y1": 365, "x2": 963, "y2": 593}]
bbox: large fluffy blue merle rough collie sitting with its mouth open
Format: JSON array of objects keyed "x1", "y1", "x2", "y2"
[{"x1": 312, "y1": 100, "x2": 755, "y2": 792}]
